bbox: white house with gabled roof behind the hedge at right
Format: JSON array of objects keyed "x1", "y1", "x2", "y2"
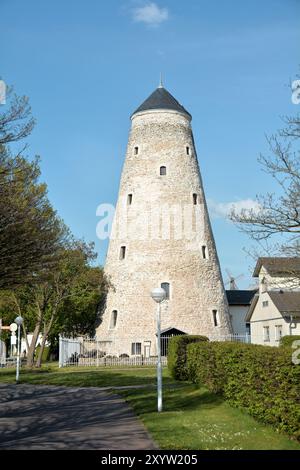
[{"x1": 245, "y1": 258, "x2": 300, "y2": 346}]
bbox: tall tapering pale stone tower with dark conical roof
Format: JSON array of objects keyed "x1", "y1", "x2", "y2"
[{"x1": 96, "y1": 85, "x2": 231, "y2": 356}]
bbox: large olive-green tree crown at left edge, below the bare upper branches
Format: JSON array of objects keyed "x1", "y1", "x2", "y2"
[{"x1": 0, "y1": 151, "x2": 69, "y2": 289}]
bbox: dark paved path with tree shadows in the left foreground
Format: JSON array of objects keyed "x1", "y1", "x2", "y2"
[{"x1": 0, "y1": 384, "x2": 157, "y2": 450}]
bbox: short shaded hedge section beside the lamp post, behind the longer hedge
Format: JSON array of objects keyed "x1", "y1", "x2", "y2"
[{"x1": 168, "y1": 335, "x2": 208, "y2": 380}]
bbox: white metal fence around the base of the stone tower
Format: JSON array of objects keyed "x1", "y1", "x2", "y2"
[{"x1": 59, "y1": 335, "x2": 251, "y2": 367}]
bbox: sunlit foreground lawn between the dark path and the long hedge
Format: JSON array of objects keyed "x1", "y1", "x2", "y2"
[{"x1": 118, "y1": 384, "x2": 300, "y2": 450}]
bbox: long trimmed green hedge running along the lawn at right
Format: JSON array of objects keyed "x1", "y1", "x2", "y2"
[{"x1": 185, "y1": 342, "x2": 300, "y2": 440}]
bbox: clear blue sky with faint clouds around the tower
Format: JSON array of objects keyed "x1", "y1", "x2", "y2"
[{"x1": 0, "y1": 0, "x2": 300, "y2": 287}]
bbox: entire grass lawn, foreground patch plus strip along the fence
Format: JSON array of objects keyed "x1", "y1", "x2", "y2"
[{"x1": 0, "y1": 365, "x2": 300, "y2": 450}]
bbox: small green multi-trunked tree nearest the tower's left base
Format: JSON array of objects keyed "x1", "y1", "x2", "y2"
[{"x1": 0, "y1": 241, "x2": 108, "y2": 367}]
